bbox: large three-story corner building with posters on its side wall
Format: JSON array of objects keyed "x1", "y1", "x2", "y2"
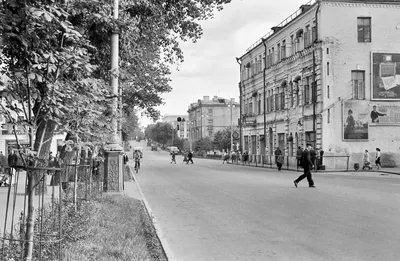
[{"x1": 237, "y1": 0, "x2": 400, "y2": 168}]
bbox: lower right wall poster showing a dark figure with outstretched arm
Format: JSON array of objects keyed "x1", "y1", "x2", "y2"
[{"x1": 369, "y1": 103, "x2": 400, "y2": 125}]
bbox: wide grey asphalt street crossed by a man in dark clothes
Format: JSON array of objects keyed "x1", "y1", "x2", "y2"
[{"x1": 137, "y1": 143, "x2": 400, "y2": 261}]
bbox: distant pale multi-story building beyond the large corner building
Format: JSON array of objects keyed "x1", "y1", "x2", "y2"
[{"x1": 188, "y1": 96, "x2": 240, "y2": 144}]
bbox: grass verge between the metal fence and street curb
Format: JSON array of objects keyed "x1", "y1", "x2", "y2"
[{"x1": 63, "y1": 195, "x2": 167, "y2": 261}]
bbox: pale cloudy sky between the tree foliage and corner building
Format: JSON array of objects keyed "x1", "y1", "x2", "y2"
[{"x1": 142, "y1": 0, "x2": 307, "y2": 125}]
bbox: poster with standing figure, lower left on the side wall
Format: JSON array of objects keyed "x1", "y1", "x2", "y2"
[{"x1": 343, "y1": 100, "x2": 370, "y2": 141}]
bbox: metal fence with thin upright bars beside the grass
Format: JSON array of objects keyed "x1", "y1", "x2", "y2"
[{"x1": 0, "y1": 156, "x2": 104, "y2": 260}]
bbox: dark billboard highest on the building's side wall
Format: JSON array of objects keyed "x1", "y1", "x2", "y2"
[{"x1": 371, "y1": 52, "x2": 400, "y2": 100}]
